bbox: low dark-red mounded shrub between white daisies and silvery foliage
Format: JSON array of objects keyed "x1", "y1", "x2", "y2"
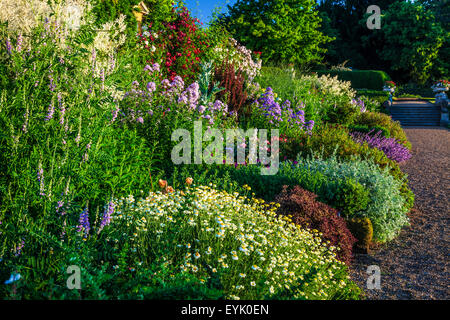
[{"x1": 275, "y1": 186, "x2": 356, "y2": 265}]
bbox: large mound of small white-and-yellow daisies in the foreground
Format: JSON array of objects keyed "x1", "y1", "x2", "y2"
[{"x1": 105, "y1": 184, "x2": 359, "y2": 299}]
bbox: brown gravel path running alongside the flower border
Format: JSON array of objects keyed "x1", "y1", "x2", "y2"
[{"x1": 351, "y1": 127, "x2": 450, "y2": 300}]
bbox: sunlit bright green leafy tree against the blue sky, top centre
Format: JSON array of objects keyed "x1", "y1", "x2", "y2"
[{"x1": 218, "y1": 0, "x2": 330, "y2": 64}]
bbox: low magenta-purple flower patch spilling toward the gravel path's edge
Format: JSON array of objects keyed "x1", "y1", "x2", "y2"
[{"x1": 350, "y1": 130, "x2": 411, "y2": 162}]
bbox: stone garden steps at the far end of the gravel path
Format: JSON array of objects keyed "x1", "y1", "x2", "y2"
[{"x1": 389, "y1": 99, "x2": 441, "y2": 126}]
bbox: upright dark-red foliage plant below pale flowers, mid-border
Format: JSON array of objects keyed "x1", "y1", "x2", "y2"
[{"x1": 214, "y1": 61, "x2": 247, "y2": 115}]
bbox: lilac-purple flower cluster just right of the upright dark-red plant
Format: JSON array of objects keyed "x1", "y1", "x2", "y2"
[{"x1": 256, "y1": 87, "x2": 314, "y2": 132}]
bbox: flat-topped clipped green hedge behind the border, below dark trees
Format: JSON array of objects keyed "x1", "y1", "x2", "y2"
[{"x1": 317, "y1": 70, "x2": 391, "y2": 90}]
